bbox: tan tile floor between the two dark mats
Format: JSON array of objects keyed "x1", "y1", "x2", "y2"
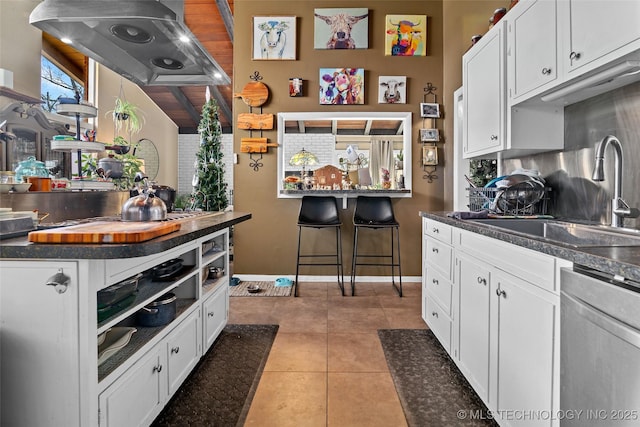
[{"x1": 229, "y1": 282, "x2": 426, "y2": 427}]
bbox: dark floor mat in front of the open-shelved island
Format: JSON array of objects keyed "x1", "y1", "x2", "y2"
[{"x1": 152, "y1": 325, "x2": 278, "y2": 427}]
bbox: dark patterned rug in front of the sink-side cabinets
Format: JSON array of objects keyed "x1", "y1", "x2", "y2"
[{"x1": 378, "y1": 329, "x2": 498, "y2": 427}]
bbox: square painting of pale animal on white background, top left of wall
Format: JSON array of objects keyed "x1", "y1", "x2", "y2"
[{"x1": 251, "y1": 16, "x2": 296, "y2": 60}]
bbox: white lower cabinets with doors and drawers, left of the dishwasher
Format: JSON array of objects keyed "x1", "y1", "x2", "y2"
[{"x1": 423, "y1": 219, "x2": 571, "y2": 427}]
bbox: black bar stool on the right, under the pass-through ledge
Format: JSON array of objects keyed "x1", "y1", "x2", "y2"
[{"x1": 351, "y1": 196, "x2": 402, "y2": 296}]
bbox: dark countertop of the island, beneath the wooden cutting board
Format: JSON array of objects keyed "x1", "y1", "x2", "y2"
[{"x1": 0, "y1": 211, "x2": 251, "y2": 259}]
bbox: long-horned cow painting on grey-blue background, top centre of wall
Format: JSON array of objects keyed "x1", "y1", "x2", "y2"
[{"x1": 313, "y1": 8, "x2": 369, "y2": 49}]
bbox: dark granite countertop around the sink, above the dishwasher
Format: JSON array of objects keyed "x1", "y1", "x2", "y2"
[{"x1": 420, "y1": 211, "x2": 640, "y2": 281}]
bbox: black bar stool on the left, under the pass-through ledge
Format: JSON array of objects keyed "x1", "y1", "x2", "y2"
[{"x1": 293, "y1": 196, "x2": 344, "y2": 297}]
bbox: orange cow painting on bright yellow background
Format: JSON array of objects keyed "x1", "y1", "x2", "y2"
[{"x1": 384, "y1": 15, "x2": 427, "y2": 56}]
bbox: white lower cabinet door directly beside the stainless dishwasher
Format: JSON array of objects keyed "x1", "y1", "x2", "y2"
[{"x1": 490, "y1": 272, "x2": 559, "y2": 426}]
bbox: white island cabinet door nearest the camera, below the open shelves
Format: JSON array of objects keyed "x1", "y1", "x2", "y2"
[{"x1": 99, "y1": 347, "x2": 167, "y2": 427}]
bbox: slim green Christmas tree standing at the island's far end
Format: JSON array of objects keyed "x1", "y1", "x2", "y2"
[{"x1": 191, "y1": 87, "x2": 229, "y2": 211}]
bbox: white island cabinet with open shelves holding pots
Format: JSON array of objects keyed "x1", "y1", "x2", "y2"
[{"x1": 0, "y1": 229, "x2": 229, "y2": 427}]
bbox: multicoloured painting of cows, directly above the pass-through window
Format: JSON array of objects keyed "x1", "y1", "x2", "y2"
[{"x1": 319, "y1": 68, "x2": 364, "y2": 105}]
